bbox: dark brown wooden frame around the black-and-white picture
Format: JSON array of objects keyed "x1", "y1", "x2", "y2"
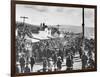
[{"x1": 11, "y1": 0, "x2": 97, "y2": 77}]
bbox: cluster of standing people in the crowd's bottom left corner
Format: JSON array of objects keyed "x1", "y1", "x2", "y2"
[{"x1": 16, "y1": 55, "x2": 35, "y2": 73}]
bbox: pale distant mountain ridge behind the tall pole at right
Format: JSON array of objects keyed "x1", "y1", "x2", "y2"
[{"x1": 60, "y1": 25, "x2": 95, "y2": 38}]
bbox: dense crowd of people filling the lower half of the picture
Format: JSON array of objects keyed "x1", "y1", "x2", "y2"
[{"x1": 16, "y1": 22, "x2": 95, "y2": 73}]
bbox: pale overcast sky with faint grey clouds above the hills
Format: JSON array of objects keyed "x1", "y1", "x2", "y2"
[{"x1": 16, "y1": 4, "x2": 94, "y2": 27}]
